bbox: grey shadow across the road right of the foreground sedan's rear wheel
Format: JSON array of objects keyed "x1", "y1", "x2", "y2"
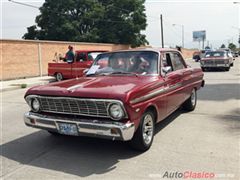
[{"x1": 198, "y1": 82, "x2": 240, "y2": 101}]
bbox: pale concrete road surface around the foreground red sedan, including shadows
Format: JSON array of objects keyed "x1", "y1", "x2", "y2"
[{"x1": 0, "y1": 58, "x2": 240, "y2": 180}]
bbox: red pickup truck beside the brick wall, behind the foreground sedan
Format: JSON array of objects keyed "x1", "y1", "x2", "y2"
[{"x1": 48, "y1": 50, "x2": 106, "y2": 81}]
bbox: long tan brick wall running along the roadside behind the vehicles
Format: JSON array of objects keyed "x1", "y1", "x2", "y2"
[{"x1": 0, "y1": 40, "x2": 194, "y2": 80}]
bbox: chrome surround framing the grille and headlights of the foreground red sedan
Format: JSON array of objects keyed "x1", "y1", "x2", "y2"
[{"x1": 25, "y1": 95, "x2": 128, "y2": 120}]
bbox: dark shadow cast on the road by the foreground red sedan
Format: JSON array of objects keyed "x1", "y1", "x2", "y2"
[{"x1": 0, "y1": 110, "x2": 182, "y2": 177}]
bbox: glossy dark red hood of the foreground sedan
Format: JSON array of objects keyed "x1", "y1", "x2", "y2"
[{"x1": 26, "y1": 76, "x2": 160, "y2": 101}]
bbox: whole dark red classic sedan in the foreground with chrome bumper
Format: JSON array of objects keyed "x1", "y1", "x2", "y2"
[{"x1": 24, "y1": 49, "x2": 204, "y2": 151}]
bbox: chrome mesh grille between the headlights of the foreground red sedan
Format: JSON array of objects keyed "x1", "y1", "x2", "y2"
[{"x1": 38, "y1": 96, "x2": 111, "y2": 117}]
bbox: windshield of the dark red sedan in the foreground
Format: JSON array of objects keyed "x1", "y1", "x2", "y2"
[{"x1": 87, "y1": 51, "x2": 158, "y2": 75}]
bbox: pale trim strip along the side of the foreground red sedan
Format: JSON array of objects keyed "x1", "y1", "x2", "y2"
[{"x1": 130, "y1": 83, "x2": 182, "y2": 104}]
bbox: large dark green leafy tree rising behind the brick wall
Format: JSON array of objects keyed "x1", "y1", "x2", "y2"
[{"x1": 23, "y1": 0, "x2": 148, "y2": 46}]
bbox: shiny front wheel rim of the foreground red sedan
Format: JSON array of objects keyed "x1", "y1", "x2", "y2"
[{"x1": 143, "y1": 114, "x2": 153, "y2": 145}]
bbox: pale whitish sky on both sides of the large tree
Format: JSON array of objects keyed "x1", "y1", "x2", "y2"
[{"x1": 0, "y1": 0, "x2": 240, "y2": 48}]
